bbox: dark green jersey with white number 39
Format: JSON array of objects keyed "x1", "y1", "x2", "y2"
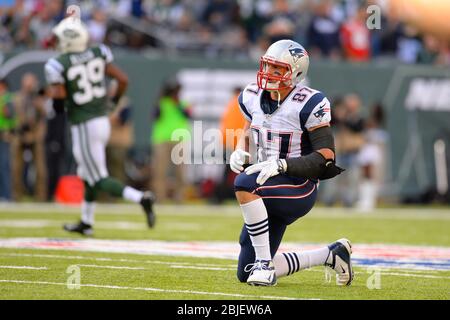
[{"x1": 45, "y1": 45, "x2": 113, "y2": 124}]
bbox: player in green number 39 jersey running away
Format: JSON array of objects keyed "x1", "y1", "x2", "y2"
[{"x1": 45, "y1": 16, "x2": 155, "y2": 235}]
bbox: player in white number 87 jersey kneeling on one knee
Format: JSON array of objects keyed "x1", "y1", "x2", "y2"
[{"x1": 230, "y1": 40, "x2": 353, "y2": 286}]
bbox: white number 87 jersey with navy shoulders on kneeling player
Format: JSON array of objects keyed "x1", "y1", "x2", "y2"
[{"x1": 238, "y1": 83, "x2": 331, "y2": 162}]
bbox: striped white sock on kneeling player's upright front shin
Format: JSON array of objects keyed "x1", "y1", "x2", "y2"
[{"x1": 241, "y1": 198, "x2": 272, "y2": 260}]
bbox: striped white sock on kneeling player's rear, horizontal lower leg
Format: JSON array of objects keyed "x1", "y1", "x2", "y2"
[{"x1": 273, "y1": 247, "x2": 330, "y2": 277}]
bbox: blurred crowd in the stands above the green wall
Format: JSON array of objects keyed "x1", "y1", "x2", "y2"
[{"x1": 0, "y1": 0, "x2": 450, "y2": 65}]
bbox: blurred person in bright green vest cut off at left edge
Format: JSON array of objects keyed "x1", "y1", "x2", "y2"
[{"x1": 0, "y1": 79, "x2": 16, "y2": 202}]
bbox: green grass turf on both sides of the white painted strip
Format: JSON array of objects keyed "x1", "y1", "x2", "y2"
[{"x1": 0, "y1": 206, "x2": 450, "y2": 300}]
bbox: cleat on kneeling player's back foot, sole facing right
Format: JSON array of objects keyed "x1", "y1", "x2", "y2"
[{"x1": 325, "y1": 239, "x2": 354, "y2": 286}]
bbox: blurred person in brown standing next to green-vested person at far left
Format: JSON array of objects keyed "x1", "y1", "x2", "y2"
[{"x1": 12, "y1": 73, "x2": 47, "y2": 201}]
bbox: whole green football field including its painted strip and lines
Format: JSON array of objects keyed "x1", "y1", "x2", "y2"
[{"x1": 0, "y1": 204, "x2": 450, "y2": 300}]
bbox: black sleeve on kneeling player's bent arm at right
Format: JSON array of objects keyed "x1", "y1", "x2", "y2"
[{"x1": 286, "y1": 127, "x2": 344, "y2": 180}]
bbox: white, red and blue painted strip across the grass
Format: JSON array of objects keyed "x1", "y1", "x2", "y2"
[{"x1": 0, "y1": 238, "x2": 450, "y2": 272}]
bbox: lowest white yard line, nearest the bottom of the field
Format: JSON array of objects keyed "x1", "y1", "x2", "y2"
[{"x1": 0, "y1": 279, "x2": 310, "y2": 300}]
